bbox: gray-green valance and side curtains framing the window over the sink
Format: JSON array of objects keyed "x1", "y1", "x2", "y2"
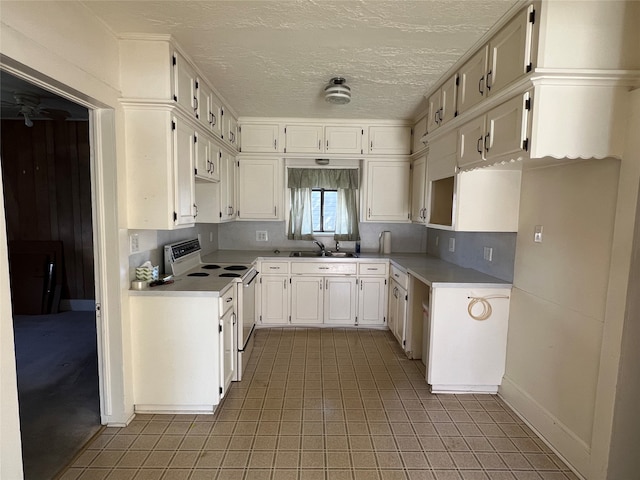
[{"x1": 287, "y1": 168, "x2": 360, "y2": 241}]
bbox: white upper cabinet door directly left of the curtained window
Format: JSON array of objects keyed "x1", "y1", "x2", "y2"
[{"x1": 238, "y1": 158, "x2": 282, "y2": 220}]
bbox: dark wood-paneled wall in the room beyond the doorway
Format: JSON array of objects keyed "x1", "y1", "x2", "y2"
[{"x1": 0, "y1": 120, "x2": 95, "y2": 299}]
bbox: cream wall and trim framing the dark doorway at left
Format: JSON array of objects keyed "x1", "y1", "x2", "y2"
[{"x1": 0, "y1": 1, "x2": 133, "y2": 479}]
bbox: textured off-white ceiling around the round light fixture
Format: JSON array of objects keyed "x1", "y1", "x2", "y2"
[{"x1": 83, "y1": 0, "x2": 515, "y2": 119}]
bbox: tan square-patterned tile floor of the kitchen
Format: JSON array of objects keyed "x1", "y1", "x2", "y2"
[{"x1": 61, "y1": 329, "x2": 577, "y2": 480}]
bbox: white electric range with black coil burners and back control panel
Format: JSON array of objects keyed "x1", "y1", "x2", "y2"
[{"x1": 164, "y1": 238, "x2": 258, "y2": 381}]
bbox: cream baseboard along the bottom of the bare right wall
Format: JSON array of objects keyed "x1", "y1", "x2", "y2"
[{"x1": 498, "y1": 376, "x2": 591, "y2": 479}]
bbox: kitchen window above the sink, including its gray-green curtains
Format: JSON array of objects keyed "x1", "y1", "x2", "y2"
[{"x1": 287, "y1": 168, "x2": 359, "y2": 241}]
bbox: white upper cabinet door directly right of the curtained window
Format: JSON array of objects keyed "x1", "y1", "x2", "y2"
[{"x1": 361, "y1": 161, "x2": 410, "y2": 222}]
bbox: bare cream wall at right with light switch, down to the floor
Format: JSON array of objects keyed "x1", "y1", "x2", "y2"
[{"x1": 500, "y1": 90, "x2": 640, "y2": 480}]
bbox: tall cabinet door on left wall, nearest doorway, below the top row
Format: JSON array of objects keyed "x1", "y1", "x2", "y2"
[{"x1": 173, "y1": 117, "x2": 195, "y2": 225}]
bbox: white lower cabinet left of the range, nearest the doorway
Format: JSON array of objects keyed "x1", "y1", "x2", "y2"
[{"x1": 130, "y1": 295, "x2": 221, "y2": 413}]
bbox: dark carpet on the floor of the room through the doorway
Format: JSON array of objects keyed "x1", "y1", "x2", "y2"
[{"x1": 14, "y1": 312, "x2": 101, "y2": 480}]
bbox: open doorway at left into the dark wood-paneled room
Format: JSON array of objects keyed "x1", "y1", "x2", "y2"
[{"x1": 0, "y1": 72, "x2": 101, "y2": 480}]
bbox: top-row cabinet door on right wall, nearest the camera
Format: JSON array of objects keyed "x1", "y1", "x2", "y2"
[{"x1": 487, "y1": 5, "x2": 533, "y2": 95}]
